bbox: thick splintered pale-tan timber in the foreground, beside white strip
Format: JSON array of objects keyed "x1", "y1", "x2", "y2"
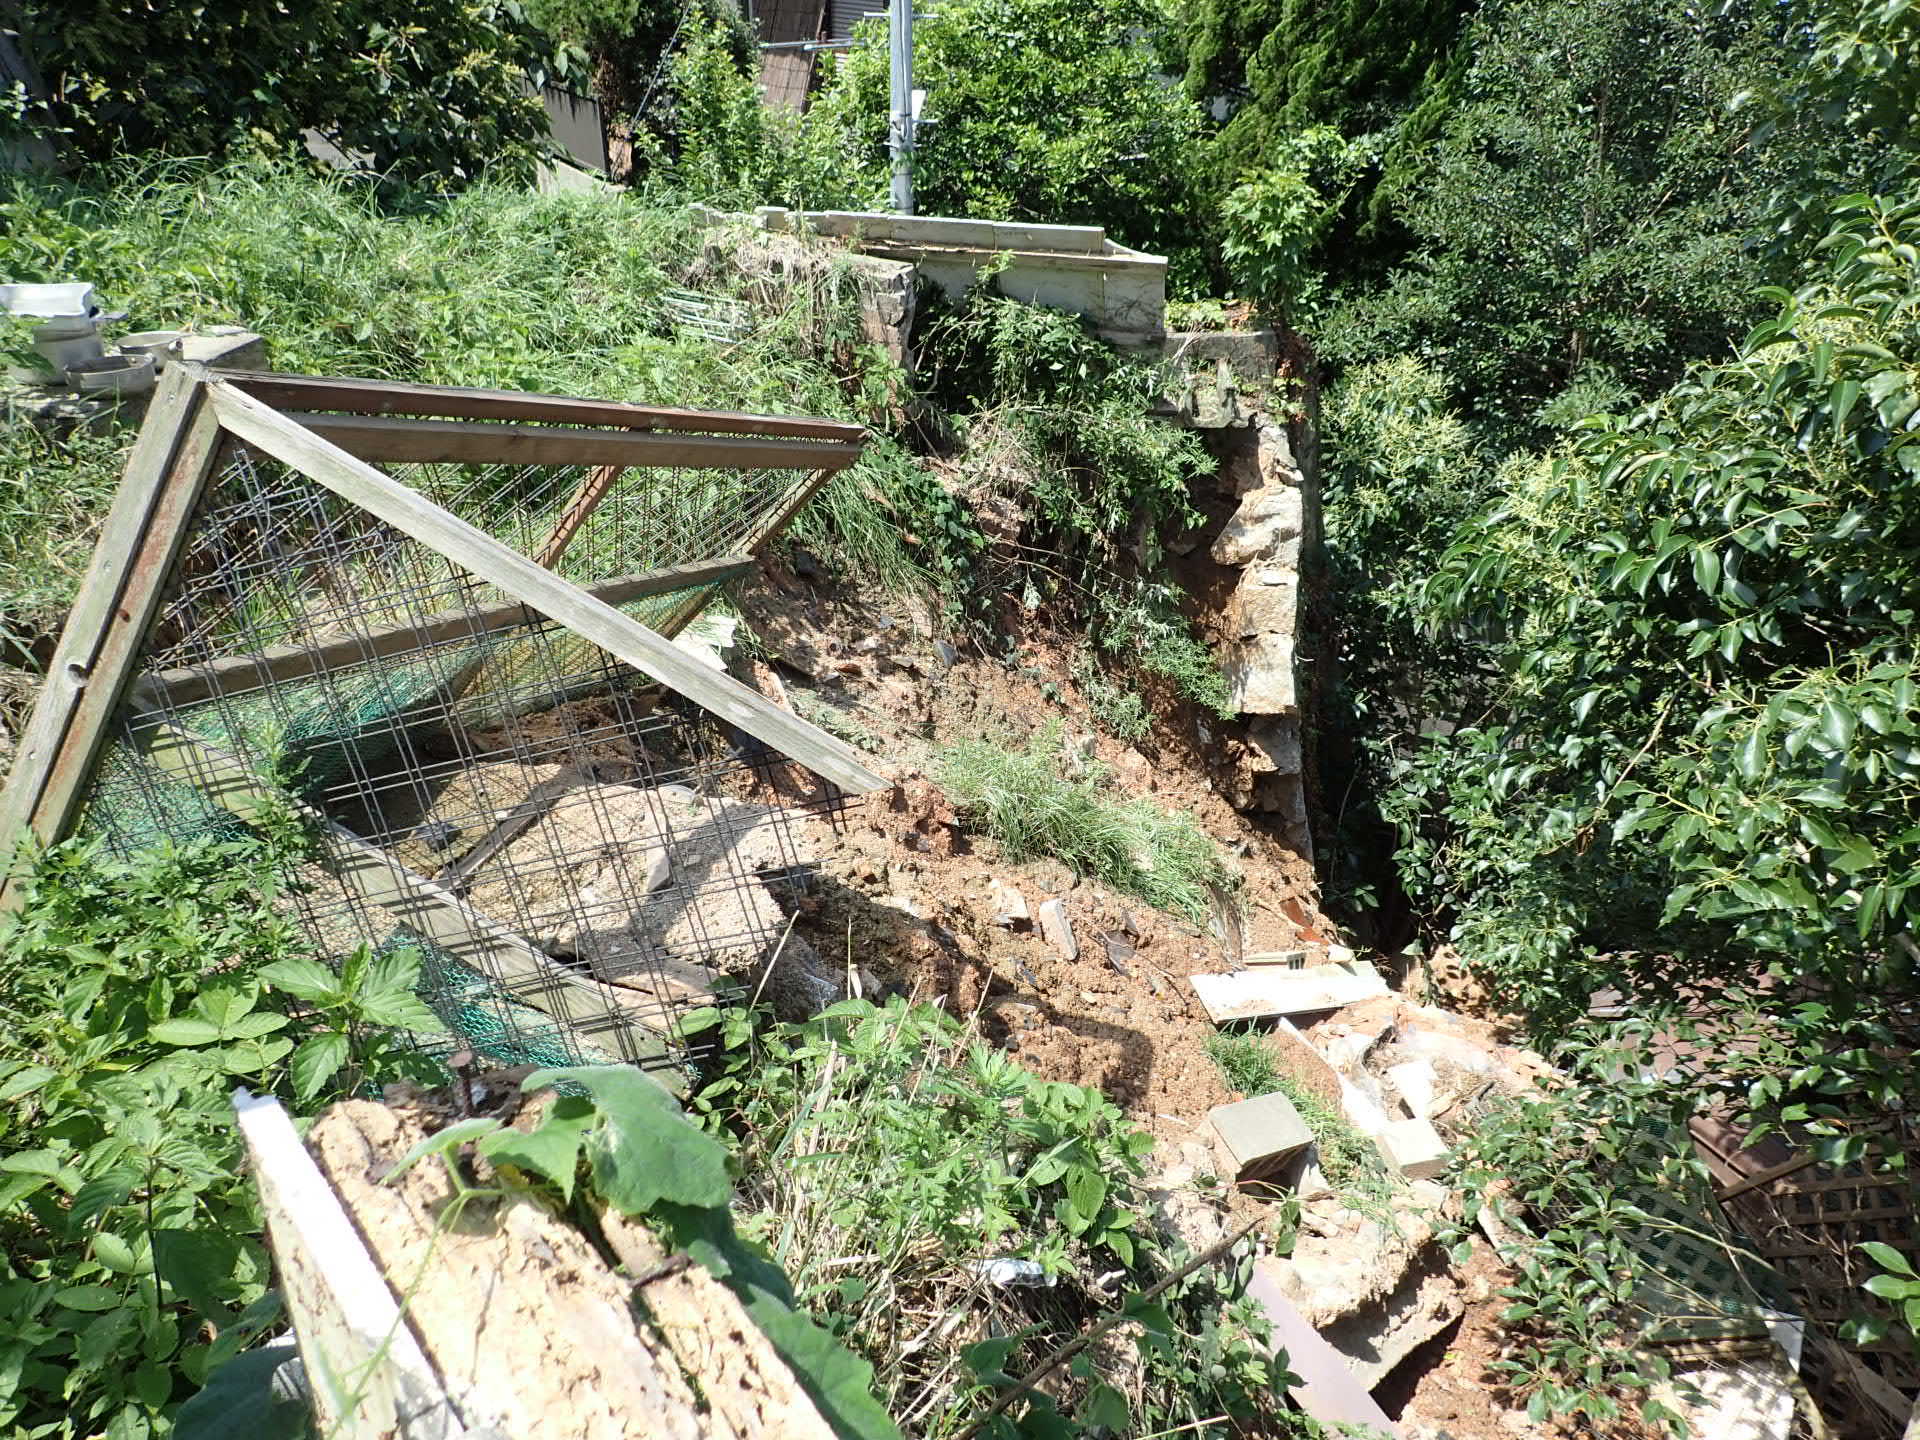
[{"x1": 307, "y1": 1100, "x2": 833, "y2": 1440}]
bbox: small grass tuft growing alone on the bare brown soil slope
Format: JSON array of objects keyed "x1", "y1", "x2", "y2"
[{"x1": 939, "y1": 724, "x2": 1238, "y2": 925}]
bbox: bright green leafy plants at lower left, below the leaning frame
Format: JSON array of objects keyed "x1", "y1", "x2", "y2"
[{"x1": 0, "y1": 839, "x2": 440, "y2": 1438}]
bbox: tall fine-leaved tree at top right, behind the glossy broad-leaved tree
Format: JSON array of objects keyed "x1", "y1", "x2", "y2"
[{"x1": 1321, "y1": 0, "x2": 1793, "y2": 434}]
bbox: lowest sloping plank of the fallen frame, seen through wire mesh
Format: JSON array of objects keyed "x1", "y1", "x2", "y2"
[{"x1": 131, "y1": 706, "x2": 678, "y2": 1083}]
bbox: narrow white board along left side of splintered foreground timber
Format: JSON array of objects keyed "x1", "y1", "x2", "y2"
[{"x1": 234, "y1": 1091, "x2": 456, "y2": 1440}]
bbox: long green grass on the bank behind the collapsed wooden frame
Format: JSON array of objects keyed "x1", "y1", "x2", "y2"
[{"x1": 0, "y1": 163, "x2": 921, "y2": 618}]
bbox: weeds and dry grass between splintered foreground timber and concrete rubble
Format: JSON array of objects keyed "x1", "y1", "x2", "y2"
[{"x1": 701, "y1": 998, "x2": 1284, "y2": 1438}]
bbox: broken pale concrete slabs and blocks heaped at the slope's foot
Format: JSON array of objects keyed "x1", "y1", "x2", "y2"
[{"x1": 1152, "y1": 960, "x2": 1835, "y2": 1440}]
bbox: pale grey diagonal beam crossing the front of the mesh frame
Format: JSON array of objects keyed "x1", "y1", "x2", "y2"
[{"x1": 209, "y1": 380, "x2": 889, "y2": 795}]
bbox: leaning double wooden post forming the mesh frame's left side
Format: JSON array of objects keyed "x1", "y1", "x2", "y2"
[{"x1": 0, "y1": 365, "x2": 221, "y2": 904}]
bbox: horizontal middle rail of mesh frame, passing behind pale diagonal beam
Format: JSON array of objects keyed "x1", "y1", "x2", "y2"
[{"x1": 140, "y1": 555, "x2": 753, "y2": 708}]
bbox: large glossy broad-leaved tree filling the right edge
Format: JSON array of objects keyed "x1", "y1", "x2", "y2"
[{"x1": 1394, "y1": 196, "x2": 1920, "y2": 1144}]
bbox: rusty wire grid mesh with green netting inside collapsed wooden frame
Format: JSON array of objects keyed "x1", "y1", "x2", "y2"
[{"x1": 10, "y1": 372, "x2": 879, "y2": 1090}]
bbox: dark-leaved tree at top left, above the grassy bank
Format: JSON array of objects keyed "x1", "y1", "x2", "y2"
[{"x1": 13, "y1": 0, "x2": 549, "y2": 182}]
